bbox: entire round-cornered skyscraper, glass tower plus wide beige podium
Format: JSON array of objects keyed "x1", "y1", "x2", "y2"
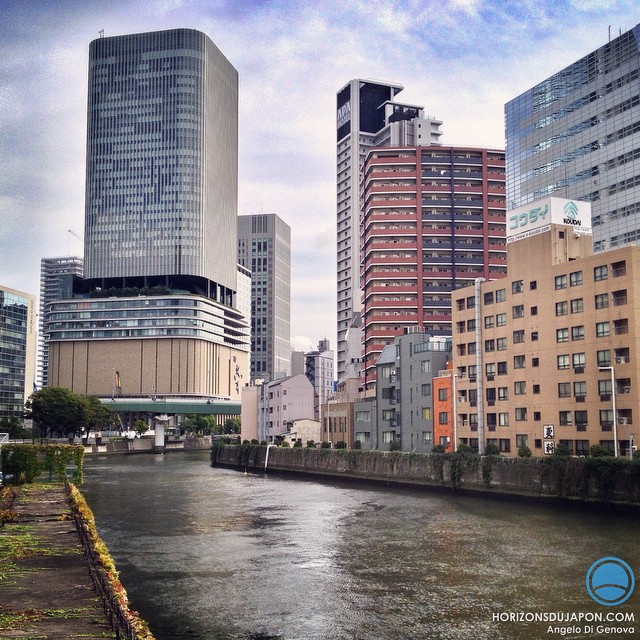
[{"x1": 48, "y1": 29, "x2": 249, "y2": 399}]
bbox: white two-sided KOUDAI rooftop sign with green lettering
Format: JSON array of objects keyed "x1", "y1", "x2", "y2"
[{"x1": 507, "y1": 197, "x2": 591, "y2": 242}]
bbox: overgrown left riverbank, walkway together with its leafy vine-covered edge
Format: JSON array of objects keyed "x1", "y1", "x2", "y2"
[{"x1": 0, "y1": 483, "x2": 153, "y2": 640}]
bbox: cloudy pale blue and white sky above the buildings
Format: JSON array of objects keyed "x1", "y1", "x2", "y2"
[{"x1": 0, "y1": 0, "x2": 640, "y2": 348}]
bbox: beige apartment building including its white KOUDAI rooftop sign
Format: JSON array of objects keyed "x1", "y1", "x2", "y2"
[{"x1": 453, "y1": 198, "x2": 640, "y2": 456}]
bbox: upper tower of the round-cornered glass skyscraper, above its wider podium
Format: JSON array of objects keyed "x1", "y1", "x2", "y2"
[{"x1": 85, "y1": 29, "x2": 238, "y2": 304}]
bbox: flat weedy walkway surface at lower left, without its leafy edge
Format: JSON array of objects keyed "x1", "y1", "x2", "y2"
[{"x1": 0, "y1": 484, "x2": 116, "y2": 640}]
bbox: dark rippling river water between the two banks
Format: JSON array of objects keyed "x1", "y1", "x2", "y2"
[{"x1": 82, "y1": 452, "x2": 640, "y2": 640}]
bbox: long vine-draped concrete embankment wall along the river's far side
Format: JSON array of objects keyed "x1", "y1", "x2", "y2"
[{"x1": 212, "y1": 444, "x2": 640, "y2": 506}]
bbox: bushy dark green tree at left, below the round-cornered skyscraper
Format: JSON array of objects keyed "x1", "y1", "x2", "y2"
[{"x1": 25, "y1": 387, "x2": 87, "y2": 437}]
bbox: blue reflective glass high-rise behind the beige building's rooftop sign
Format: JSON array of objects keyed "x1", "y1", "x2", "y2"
[{"x1": 505, "y1": 25, "x2": 640, "y2": 251}]
